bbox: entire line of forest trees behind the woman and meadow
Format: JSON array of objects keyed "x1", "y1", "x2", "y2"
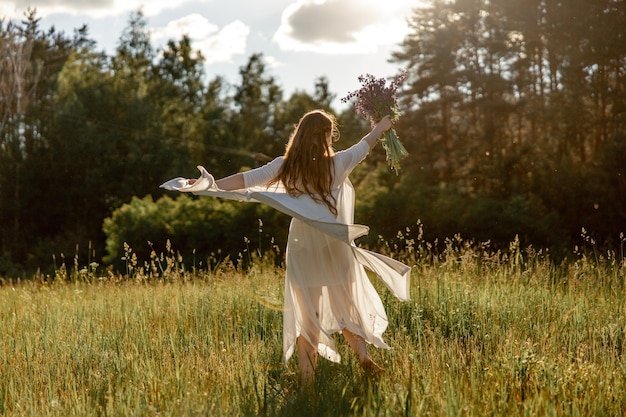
[{"x1": 0, "y1": 0, "x2": 626, "y2": 275}]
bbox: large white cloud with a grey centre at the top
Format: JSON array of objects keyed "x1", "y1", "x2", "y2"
[{"x1": 273, "y1": 0, "x2": 416, "y2": 54}]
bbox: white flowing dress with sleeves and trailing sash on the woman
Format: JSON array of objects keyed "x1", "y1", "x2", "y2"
[{"x1": 162, "y1": 140, "x2": 410, "y2": 362}]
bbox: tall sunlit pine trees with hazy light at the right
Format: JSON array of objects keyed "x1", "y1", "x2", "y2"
[{"x1": 386, "y1": 0, "x2": 626, "y2": 251}]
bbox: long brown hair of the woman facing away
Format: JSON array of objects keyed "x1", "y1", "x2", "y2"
[{"x1": 270, "y1": 110, "x2": 339, "y2": 216}]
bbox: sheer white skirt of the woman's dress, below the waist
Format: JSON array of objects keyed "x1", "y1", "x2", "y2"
[{"x1": 283, "y1": 219, "x2": 388, "y2": 362}]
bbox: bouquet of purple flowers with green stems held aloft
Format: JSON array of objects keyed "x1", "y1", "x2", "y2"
[{"x1": 341, "y1": 71, "x2": 409, "y2": 175}]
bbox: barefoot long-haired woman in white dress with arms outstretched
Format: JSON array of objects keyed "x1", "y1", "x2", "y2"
[{"x1": 164, "y1": 110, "x2": 410, "y2": 383}]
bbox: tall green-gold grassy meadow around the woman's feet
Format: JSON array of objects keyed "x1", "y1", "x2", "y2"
[{"x1": 0, "y1": 234, "x2": 626, "y2": 416}]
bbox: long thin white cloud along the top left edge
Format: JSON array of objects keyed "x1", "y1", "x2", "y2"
[{"x1": 0, "y1": 0, "x2": 212, "y2": 19}]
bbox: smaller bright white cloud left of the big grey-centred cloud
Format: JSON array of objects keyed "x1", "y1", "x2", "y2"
[{"x1": 152, "y1": 13, "x2": 250, "y2": 65}]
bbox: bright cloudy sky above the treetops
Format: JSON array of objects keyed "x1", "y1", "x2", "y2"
[{"x1": 0, "y1": 0, "x2": 422, "y2": 108}]
